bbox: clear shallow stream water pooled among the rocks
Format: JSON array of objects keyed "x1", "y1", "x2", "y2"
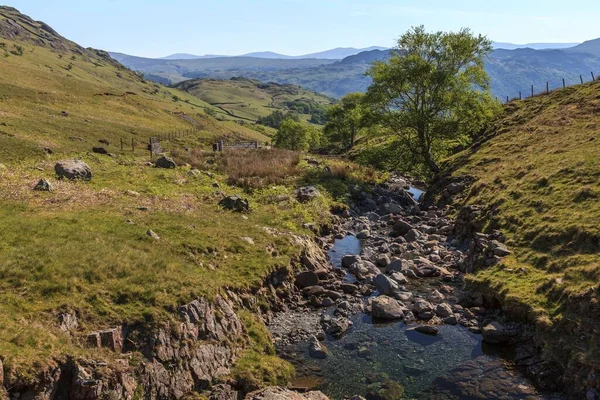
[{"x1": 282, "y1": 236, "x2": 557, "y2": 400}]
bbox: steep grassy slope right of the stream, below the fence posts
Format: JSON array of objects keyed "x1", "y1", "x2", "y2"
[{"x1": 440, "y1": 82, "x2": 600, "y2": 376}]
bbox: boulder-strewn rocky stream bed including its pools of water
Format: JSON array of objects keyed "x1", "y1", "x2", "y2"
[{"x1": 269, "y1": 178, "x2": 561, "y2": 400}]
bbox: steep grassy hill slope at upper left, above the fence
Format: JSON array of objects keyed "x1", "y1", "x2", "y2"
[{"x1": 0, "y1": 7, "x2": 268, "y2": 162}]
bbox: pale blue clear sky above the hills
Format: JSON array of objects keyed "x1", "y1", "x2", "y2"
[{"x1": 9, "y1": 0, "x2": 600, "y2": 57}]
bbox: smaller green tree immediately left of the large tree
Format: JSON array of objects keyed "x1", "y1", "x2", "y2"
[{"x1": 325, "y1": 93, "x2": 367, "y2": 150}]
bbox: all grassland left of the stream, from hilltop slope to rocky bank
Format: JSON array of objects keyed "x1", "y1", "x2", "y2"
[{"x1": 0, "y1": 7, "x2": 384, "y2": 382}]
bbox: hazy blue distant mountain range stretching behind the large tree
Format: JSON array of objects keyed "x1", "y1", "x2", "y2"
[{"x1": 117, "y1": 39, "x2": 600, "y2": 99}]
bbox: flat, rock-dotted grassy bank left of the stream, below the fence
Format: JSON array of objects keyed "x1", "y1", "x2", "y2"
[{"x1": 0, "y1": 153, "x2": 338, "y2": 378}]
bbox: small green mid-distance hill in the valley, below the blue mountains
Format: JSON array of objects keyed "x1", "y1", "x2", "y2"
[{"x1": 175, "y1": 78, "x2": 333, "y2": 122}]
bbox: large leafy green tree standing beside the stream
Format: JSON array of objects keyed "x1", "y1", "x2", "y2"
[{"x1": 367, "y1": 26, "x2": 499, "y2": 173}]
